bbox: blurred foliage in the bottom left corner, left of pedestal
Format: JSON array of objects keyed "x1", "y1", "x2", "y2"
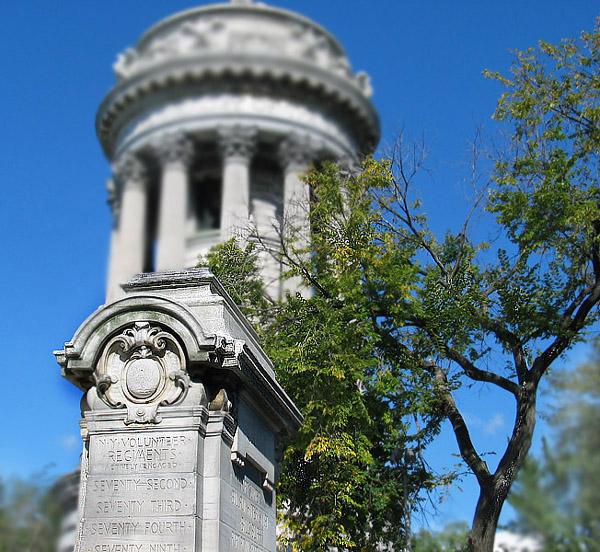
[{"x1": 0, "y1": 476, "x2": 60, "y2": 552}]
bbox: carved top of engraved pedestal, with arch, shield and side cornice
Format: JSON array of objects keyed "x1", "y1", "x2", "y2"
[{"x1": 55, "y1": 269, "x2": 302, "y2": 432}]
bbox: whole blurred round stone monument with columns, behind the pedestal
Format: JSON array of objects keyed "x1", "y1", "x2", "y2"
[{"x1": 96, "y1": 0, "x2": 379, "y2": 299}]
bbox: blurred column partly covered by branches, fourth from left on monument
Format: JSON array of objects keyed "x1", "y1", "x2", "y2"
[{"x1": 279, "y1": 137, "x2": 315, "y2": 294}]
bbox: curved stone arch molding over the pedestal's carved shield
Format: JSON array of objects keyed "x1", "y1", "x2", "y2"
[{"x1": 55, "y1": 294, "x2": 215, "y2": 389}]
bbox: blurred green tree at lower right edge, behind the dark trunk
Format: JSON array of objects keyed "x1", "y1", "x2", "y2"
[{"x1": 509, "y1": 342, "x2": 600, "y2": 552}]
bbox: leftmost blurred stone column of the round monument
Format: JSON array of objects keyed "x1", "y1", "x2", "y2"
[{"x1": 106, "y1": 153, "x2": 148, "y2": 302}]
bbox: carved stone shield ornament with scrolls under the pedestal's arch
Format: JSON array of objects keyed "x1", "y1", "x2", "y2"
[{"x1": 94, "y1": 322, "x2": 190, "y2": 424}]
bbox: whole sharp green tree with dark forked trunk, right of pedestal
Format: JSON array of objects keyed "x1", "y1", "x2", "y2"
[{"x1": 207, "y1": 19, "x2": 600, "y2": 552}]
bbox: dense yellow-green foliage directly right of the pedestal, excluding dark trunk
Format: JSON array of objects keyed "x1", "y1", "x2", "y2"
[{"x1": 208, "y1": 160, "x2": 439, "y2": 551}]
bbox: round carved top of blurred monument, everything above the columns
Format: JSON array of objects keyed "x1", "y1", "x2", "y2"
[{"x1": 97, "y1": 2, "x2": 379, "y2": 159}]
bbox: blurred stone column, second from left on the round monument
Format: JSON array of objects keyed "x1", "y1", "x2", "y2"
[{"x1": 155, "y1": 133, "x2": 194, "y2": 270}]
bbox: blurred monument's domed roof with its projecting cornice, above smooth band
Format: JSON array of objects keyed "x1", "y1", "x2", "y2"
[{"x1": 97, "y1": 0, "x2": 379, "y2": 155}]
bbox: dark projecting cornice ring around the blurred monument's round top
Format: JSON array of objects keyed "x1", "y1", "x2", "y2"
[{"x1": 96, "y1": 54, "x2": 380, "y2": 157}]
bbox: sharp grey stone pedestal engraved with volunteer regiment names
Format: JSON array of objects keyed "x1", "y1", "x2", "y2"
[{"x1": 55, "y1": 269, "x2": 301, "y2": 552}]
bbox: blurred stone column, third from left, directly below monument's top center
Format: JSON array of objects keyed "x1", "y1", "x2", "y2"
[{"x1": 219, "y1": 127, "x2": 256, "y2": 241}]
